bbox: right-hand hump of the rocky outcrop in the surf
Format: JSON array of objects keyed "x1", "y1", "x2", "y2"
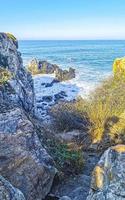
[{"x1": 55, "y1": 67, "x2": 75, "y2": 81}]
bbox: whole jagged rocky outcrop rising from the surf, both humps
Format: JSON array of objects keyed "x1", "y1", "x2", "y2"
[{"x1": 28, "y1": 58, "x2": 75, "y2": 81}]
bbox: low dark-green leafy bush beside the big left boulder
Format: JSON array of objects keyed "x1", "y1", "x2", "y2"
[{"x1": 47, "y1": 140, "x2": 84, "y2": 175}]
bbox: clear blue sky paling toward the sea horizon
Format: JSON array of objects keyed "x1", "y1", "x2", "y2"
[{"x1": 0, "y1": 0, "x2": 125, "y2": 39}]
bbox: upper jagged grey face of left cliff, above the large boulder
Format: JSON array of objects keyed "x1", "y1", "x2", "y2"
[{"x1": 0, "y1": 33, "x2": 34, "y2": 112}]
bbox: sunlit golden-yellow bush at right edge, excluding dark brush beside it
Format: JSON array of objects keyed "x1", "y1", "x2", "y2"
[{"x1": 87, "y1": 78, "x2": 125, "y2": 143}]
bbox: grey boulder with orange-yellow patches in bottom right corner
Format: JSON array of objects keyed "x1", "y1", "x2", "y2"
[{"x1": 87, "y1": 145, "x2": 125, "y2": 200}]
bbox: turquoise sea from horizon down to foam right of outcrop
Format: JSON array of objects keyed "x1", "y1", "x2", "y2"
[{"x1": 19, "y1": 40, "x2": 125, "y2": 93}]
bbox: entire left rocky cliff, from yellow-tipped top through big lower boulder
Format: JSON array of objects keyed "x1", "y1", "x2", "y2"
[{"x1": 0, "y1": 33, "x2": 56, "y2": 200}]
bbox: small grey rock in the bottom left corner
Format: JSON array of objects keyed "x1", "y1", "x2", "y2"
[{"x1": 0, "y1": 176, "x2": 25, "y2": 200}]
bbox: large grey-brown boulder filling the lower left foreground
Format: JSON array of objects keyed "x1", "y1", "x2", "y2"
[{"x1": 0, "y1": 108, "x2": 56, "y2": 200}]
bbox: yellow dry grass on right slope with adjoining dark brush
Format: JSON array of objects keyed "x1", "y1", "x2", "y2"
[{"x1": 53, "y1": 77, "x2": 125, "y2": 143}]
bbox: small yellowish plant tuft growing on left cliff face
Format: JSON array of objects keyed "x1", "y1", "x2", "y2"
[{"x1": 0, "y1": 68, "x2": 11, "y2": 85}]
